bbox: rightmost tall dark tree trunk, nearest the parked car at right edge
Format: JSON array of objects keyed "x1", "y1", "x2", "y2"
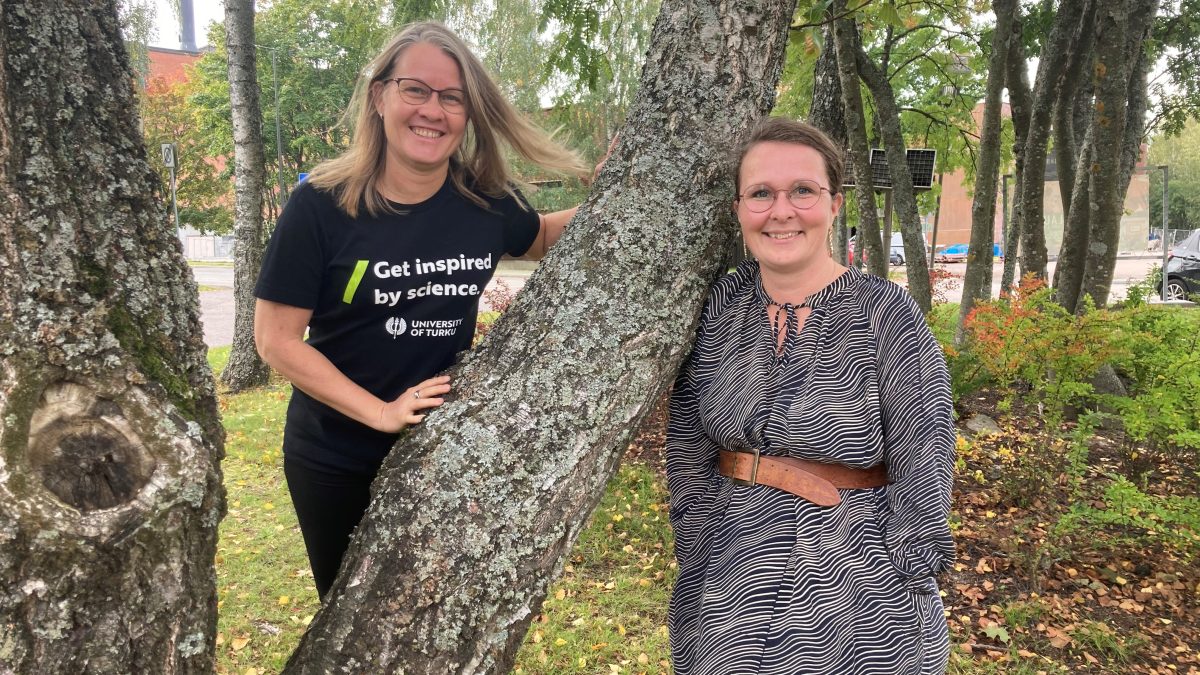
[{"x1": 1075, "y1": 0, "x2": 1158, "y2": 310}]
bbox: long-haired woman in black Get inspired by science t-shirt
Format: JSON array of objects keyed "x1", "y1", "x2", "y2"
[{"x1": 254, "y1": 23, "x2": 584, "y2": 598}]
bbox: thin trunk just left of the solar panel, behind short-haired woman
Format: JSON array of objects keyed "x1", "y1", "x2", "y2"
[{"x1": 830, "y1": 7, "x2": 888, "y2": 279}]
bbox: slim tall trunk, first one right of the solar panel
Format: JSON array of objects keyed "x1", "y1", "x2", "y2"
[{"x1": 955, "y1": 0, "x2": 1016, "y2": 342}]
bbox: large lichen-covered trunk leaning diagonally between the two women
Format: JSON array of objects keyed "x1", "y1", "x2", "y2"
[{"x1": 286, "y1": 0, "x2": 794, "y2": 674}]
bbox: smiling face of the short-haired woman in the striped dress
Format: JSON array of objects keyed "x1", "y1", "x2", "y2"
[{"x1": 733, "y1": 141, "x2": 842, "y2": 275}]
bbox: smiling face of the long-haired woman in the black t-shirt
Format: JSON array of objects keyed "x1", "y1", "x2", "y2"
[{"x1": 372, "y1": 42, "x2": 467, "y2": 179}]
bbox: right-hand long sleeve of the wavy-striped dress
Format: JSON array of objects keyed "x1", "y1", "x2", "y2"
[{"x1": 877, "y1": 295, "x2": 954, "y2": 581}]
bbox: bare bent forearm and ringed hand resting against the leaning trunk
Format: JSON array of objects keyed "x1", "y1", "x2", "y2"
[{"x1": 254, "y1": 299, "x2": 450, "y2": 434}]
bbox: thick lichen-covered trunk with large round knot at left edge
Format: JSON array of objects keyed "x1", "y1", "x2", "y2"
[{"x1": 0, "y1": 0, "x2": 224, "y2": 674}]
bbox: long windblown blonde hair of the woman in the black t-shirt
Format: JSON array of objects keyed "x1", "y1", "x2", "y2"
[{"x1": 307, "y1": 22, "x2": 588, "y2": 217}]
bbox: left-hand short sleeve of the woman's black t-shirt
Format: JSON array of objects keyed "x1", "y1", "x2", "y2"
[{"x1": 254, "y1": 184, "x2": 325, "y2": 310}]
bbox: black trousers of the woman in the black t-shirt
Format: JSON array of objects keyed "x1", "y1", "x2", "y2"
[{"x1": 283, "y1": 456, "x2": 376, "y2": 601}]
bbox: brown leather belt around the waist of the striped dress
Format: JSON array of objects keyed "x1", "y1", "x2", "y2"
[{"x1": 716, "y1": 449, "x2": 888, "y2": 506}]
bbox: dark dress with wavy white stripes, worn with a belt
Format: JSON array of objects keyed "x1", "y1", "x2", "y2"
[{"x1": 667, "y1": 261, "x2": 954, "y2": 675}]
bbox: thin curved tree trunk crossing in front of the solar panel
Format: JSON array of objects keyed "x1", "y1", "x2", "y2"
[{"x1": 856, "y1": 44, "x2": 934, "y2": 313}]
